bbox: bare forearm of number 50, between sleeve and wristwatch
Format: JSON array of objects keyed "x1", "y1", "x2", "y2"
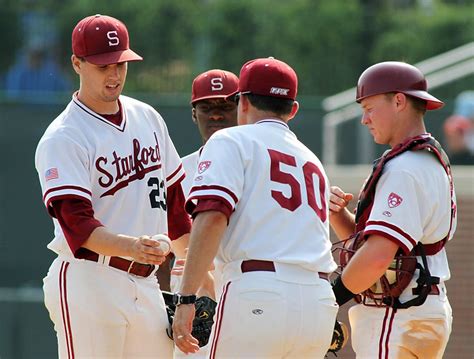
[{"x1": 180, "y1": 211, "x2": 227, "y2": 294}]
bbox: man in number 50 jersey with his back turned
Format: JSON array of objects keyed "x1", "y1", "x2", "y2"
[{"x1": 173, "y1": 58, "x2": 338, "y2": 358}]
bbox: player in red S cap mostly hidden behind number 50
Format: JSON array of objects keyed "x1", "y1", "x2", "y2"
[{"x1": 170, "y1": 69, "x2": 239, "y2": 358}]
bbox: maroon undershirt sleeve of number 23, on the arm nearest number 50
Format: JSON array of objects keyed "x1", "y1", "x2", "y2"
[{"x1": 166, "y1": 182, "x2": 191, "y2": 240}]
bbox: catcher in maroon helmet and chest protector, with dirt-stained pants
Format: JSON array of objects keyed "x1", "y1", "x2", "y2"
[{"x1": 330, "y1": 62, "x2": 456, "y2": 359}]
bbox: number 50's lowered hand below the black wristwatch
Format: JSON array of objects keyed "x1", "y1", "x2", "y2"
[{"x1": 173, "y1": 304, "x2": 199, "y2": 354}]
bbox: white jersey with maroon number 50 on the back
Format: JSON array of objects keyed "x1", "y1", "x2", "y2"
[{"x1": 188, "y1": 120, "x2": 336, "y2": 280}]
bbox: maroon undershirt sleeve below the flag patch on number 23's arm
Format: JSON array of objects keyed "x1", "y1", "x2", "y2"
[{"x1": 50, "y1": 198, "x2": 103, "y2": 256}]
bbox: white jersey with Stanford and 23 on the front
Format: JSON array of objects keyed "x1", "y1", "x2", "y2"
[{"x1": 35, "y1": 96, "x2": 184, "y2": 256}]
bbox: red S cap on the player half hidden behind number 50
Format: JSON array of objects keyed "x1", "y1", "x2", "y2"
[{"x1": 191, "y1": 69, "x2": 239, "y2": 104}]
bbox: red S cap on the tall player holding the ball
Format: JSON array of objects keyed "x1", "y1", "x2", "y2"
[{"x1": 72, "y1": 14, "x2": 143, "y2": 65}]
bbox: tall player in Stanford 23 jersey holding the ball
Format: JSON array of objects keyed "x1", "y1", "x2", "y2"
[{"x1": 35, "y1": 15, "x2": 190, "y2": 358}]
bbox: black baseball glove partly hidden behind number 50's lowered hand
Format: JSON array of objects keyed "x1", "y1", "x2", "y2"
[{"x1": 163, "y1": 291, "x2": 217, "y2": 347}]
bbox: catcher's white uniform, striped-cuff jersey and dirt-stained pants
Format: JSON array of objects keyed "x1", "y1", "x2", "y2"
[{"x1": 349, "y1": 151, "x2": 456, "y2": 359}]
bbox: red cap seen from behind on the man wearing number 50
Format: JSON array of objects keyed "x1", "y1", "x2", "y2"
[{"x1": 232, "y1": 57, "x2": 298, "y2": 100}]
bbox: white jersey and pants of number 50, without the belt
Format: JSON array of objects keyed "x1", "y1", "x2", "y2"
[{"x1": 184, "y1": 120, "x2": 338, "y2": 358}]
